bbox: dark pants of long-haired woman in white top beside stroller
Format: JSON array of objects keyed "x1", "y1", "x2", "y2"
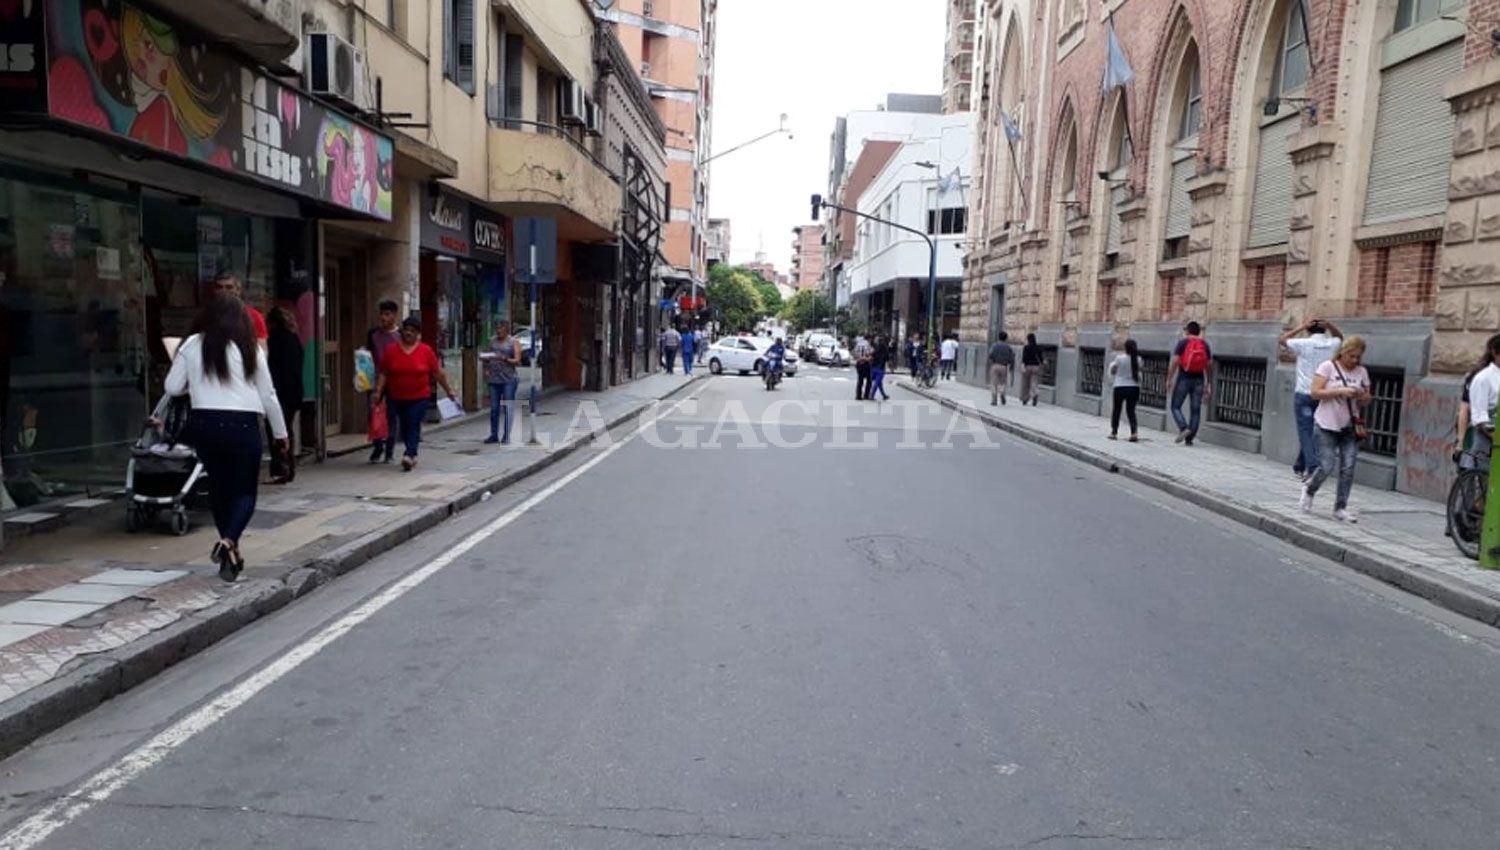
[{"x1": 188, "y1": 409, "x2": 261, "y2": 544}]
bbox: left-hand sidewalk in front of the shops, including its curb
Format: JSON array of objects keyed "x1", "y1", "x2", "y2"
[{"x1": 0, "y1": 373, "x2": 692, "y2": 757}]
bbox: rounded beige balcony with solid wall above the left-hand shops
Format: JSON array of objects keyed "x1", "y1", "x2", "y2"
[{"x1": 489, "y1": 118, "x2": 623, "y2": 241}]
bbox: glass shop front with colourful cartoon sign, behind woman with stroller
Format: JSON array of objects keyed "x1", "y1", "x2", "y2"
[{"x1": 0, "y1": 0, "x2": 392, "y2": 510}]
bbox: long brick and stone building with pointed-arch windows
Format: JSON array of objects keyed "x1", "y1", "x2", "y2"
[{"x1": 962, "y1": 0, "x2": 1500, "y2": 498}]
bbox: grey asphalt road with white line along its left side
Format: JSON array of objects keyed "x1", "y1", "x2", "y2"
[{"x1": 0, "y1": 369, "x2": 1500, "y2": 850}]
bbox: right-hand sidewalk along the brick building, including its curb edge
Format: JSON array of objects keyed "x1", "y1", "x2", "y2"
[{"x1": 902, "y1": 381, "x2": 1500, "y2": 625}]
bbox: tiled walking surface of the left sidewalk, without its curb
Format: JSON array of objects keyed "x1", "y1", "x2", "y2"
[{"x1": 0, "y1": 375, "x2": 687, "y2": 722}]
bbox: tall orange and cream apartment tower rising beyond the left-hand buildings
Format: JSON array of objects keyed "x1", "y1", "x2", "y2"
[{"x1": 600, "y1": 0, "x2": 719, "y2": 305}]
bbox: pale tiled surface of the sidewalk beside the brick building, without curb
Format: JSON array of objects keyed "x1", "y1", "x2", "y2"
[{"x1": 903, "y1": 381, "x2": 1500, "y2": 619}]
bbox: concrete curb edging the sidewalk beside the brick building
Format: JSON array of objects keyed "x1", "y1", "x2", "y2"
[{"x1": 899, "y1": 381, "x2": 1500, "y2": 625}]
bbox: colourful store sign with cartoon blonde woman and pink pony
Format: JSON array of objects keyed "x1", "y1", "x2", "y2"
[{"x1": 37, "y1": 0, "x2": 396, "y2": 220}]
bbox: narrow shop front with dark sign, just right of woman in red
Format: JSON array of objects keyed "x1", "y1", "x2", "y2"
[{"x1": 419, "y1": 184, "x2": 507, "y2": 411}]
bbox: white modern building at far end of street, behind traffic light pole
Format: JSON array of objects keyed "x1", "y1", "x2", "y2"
[{"x1": 846, "y1": 112, "x2": 974, "y2": 337}]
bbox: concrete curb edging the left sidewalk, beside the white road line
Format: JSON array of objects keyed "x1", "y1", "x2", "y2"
[{"x1": 0, "y1": 376, "x2": 702, "y2": 759}]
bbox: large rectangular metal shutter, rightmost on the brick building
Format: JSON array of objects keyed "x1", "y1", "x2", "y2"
[{"x1": 1365, "y1": 39, "x2": 1464, "y2": 225}]
